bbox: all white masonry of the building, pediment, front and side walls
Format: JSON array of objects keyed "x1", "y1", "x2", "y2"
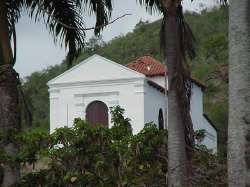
[{"x1": 48, "y1": 55, "x2": 217, "y2": 151}]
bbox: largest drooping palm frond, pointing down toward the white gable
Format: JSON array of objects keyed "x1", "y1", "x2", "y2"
[{"x1": 25, "y1": 0, "x2": 85, "y2": 63}]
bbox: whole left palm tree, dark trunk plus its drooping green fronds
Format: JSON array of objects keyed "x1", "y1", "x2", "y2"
[{"x1": 0, "y1": 0, "x2": 112, "y2": 186}]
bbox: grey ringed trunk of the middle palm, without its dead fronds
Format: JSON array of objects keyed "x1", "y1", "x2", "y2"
[{"x1": 164, "y1": 5, "x2": 187, "y2": 187}]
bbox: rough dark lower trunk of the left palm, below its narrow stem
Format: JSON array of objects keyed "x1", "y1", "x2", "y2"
[{"x1": 0, "y1": 64, "x2": 20, "y2": 187}]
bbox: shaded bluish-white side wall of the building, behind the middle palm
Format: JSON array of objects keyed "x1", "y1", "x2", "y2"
[{"x1": 144, "y1": 79, "x2": 217, "y2": 152}]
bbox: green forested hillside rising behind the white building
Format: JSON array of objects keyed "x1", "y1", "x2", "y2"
[{"x1": 23, "y1": 8, "x2": 228, "y2": 156}]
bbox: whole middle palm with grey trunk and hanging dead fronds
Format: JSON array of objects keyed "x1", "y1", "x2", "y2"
[{"x1": 138, "y1": 0, "x2": 195, "y2": 187}]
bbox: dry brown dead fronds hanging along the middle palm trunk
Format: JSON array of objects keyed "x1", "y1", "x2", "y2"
[{"x1": 160, "y1": 5, "x2": 196, "y2": 147}]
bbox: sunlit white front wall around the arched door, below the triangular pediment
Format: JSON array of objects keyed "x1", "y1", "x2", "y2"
[{"x1": 50, "y1": 79, "x2": 144, "y2": 133}]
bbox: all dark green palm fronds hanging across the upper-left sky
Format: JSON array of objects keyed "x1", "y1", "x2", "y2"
[{"x1": 6, "y1": 0, "x2": 112, "y2": 63}]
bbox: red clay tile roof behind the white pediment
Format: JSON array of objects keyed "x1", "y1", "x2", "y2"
[{"x1": 127, "y1": 56, "x2": 207, "y2": 90}]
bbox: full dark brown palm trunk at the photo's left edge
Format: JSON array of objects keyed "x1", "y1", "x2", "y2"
[{"x1": 0, "y1": 0, "x2": 20, "y2": 187}]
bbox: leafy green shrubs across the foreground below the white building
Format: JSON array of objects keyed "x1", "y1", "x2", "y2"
[{"x1": 0, "y1": 106, "x2": 225, "y2": 187}]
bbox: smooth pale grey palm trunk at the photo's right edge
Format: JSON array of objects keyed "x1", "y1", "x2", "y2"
[{"x1": 228, "y1": 0, "x2": 250, "y2": 187}]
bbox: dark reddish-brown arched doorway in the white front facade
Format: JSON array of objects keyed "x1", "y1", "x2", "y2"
[{"x1": 86, "y1": 101, "x2": 109, "y2": 127}]
